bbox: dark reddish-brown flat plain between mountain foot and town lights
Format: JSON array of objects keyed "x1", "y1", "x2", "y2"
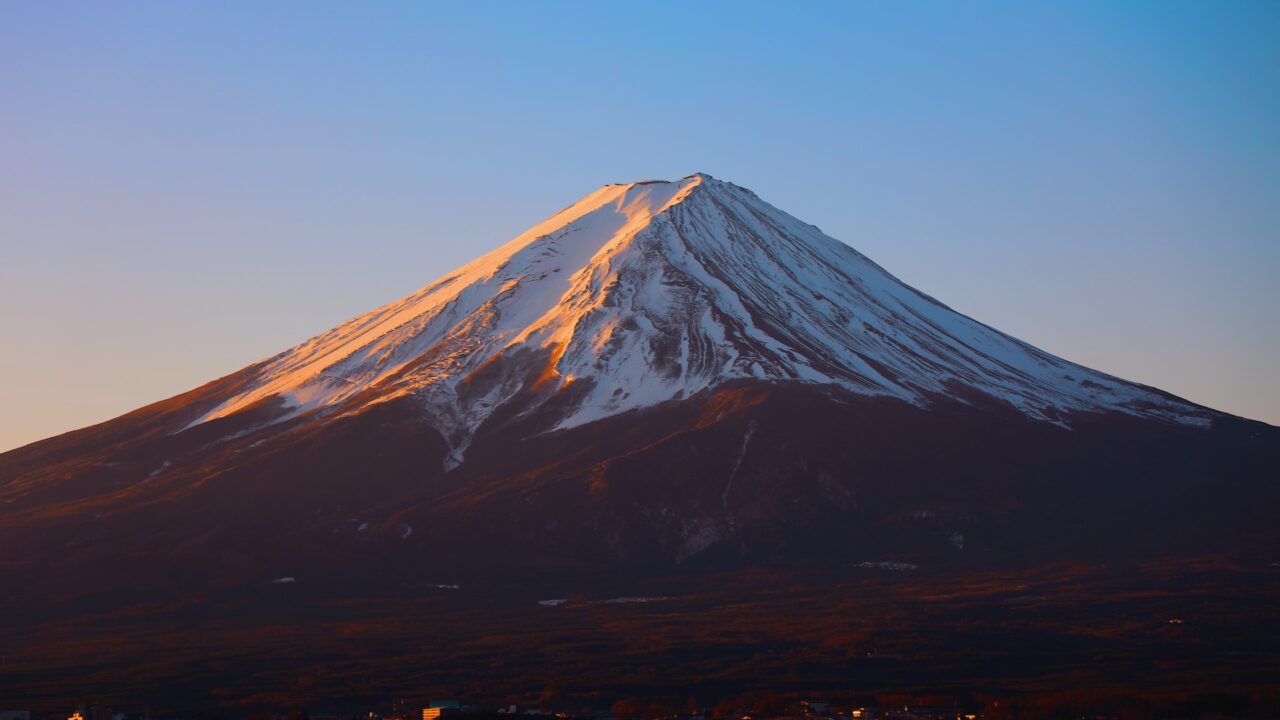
[{"x1": 0, "y1": 557, "x2": 1280, "y2": 714}]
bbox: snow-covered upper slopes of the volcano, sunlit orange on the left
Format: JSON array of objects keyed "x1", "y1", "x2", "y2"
[{"x1": 198, "y1": 174, "x2": 1212, "y2": 461}]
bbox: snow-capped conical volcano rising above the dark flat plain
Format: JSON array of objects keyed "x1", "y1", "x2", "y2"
[{"x1": 0, "y1": 174, "x2": 1280, "y2": 707}]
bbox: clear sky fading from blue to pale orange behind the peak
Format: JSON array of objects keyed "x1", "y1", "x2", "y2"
[{"x1": 0, "y1": 0, "x2": 1280, "y2": 450}]
